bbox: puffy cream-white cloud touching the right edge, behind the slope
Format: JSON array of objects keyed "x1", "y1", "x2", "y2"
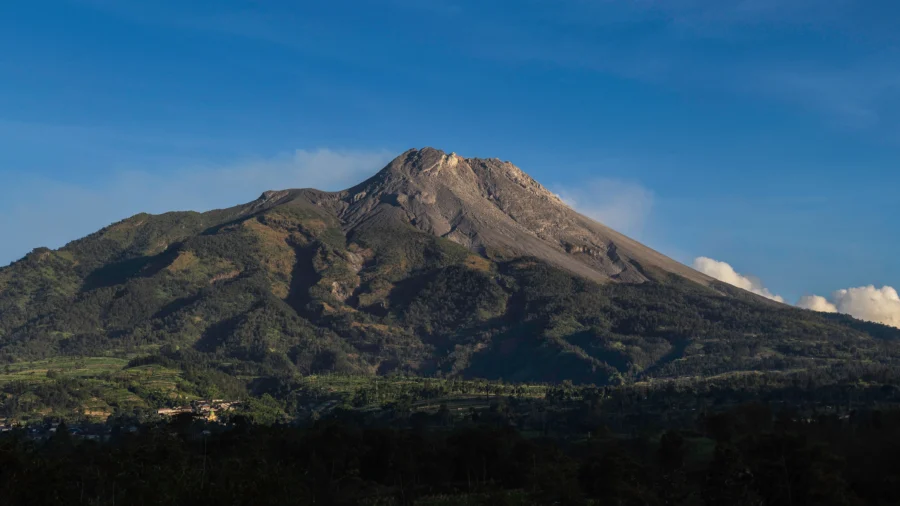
[{"x1": 797, "y1": 285, "x2": 900, "y2": 328}]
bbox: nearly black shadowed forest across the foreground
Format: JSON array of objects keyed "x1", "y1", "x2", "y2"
[{"x1": 0, "y1": 402, "x2": 900, "y2": 506}]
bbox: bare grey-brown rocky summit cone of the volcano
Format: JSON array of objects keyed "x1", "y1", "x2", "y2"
[{"x1": 265, "y1": 148, "x2": 710, "y2": 284}]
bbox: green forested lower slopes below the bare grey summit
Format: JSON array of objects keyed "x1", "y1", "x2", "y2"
[{"x1": 0, "y1": 194, "x2": 900, "y2": 417}]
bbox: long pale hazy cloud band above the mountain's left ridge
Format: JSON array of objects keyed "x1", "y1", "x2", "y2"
[{"x1": 0, "y1": 149, "x2": 393, "y2": 266}]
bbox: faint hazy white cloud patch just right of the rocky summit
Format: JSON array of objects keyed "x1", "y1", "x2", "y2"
[{"x1": 554, "y1": 178, "x2": 653, "y2": 236}]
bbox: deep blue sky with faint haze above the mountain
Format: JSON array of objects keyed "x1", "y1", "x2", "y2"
[{"x1": 0, "y1": 0, "x2": 900, "y2": 308}]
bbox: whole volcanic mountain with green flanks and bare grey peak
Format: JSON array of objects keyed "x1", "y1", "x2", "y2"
[{"x1": 0, "y1": 149, "x2": 900, "y2": 406}]
